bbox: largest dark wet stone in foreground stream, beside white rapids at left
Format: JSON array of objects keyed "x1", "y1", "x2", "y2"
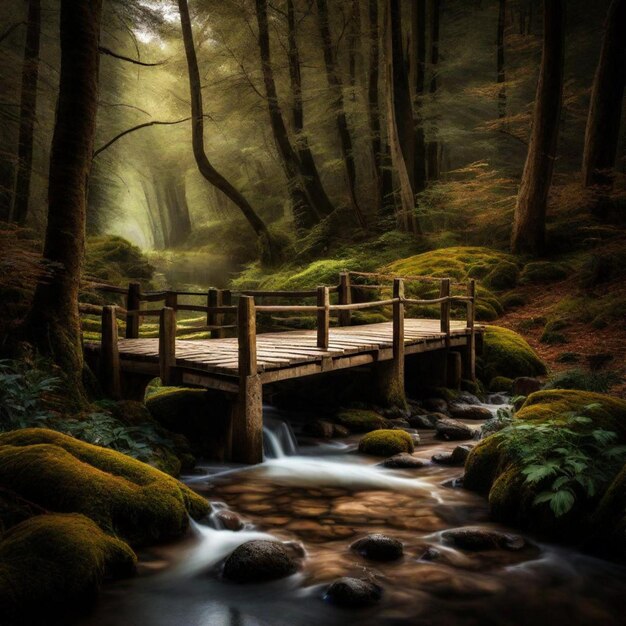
[{"x1": 224, "y1": 539, "x2": 298, "y2": 583}]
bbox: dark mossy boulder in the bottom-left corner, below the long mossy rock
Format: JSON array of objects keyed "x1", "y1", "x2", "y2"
[{"x1": 0, "y1": 514, "x2": 136, "y2": 624}]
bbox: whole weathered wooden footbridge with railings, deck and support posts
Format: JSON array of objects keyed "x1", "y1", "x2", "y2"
[{"x1": 83, "y1": 272, "x2": 482, "y2": 463}]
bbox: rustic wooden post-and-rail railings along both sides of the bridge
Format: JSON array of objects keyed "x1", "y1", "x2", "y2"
[{"x1": 82, "y1": 272, "x2": 476, "y2": 392}]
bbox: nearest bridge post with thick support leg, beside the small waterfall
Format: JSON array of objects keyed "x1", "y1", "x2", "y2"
[{"x1": 232, "y1": 296, "x2": 263, "y2": 464}]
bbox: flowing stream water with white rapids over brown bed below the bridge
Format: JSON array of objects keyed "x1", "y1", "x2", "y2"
[{"x1": 81, "y1": 397, "x2": 626, "y2": 626}]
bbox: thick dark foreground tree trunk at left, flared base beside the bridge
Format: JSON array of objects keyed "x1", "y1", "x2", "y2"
[{"x1": 25, "y1": 0, "x2": 102, "y2": 402}]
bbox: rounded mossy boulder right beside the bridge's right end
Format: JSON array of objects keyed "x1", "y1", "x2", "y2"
[{"x1": 479, "y1": 326, "x2": 547, "y2": 382}]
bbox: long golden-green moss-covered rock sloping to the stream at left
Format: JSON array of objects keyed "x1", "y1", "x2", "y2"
[{"x1": 0, "y1": 428, "x2": 208, "y2": 545}]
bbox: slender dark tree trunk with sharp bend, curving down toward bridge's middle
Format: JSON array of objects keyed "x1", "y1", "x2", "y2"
[{"x1": 178, "y1": 0, "x2": 275, "y2": 260}]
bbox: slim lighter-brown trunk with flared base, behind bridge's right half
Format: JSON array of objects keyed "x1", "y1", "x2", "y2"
[{"x1": 386, "y1": 0, "x2": 419, "y2": 232}]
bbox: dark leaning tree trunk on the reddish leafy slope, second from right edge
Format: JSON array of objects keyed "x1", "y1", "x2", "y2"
[{"x1": 511, "y1": 0, "x2": 565, "y2": 254}]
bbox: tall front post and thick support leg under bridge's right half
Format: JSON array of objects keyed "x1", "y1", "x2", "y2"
[{"x1": 374, "y1": 278, "x2": 407, "y2": 411}]
